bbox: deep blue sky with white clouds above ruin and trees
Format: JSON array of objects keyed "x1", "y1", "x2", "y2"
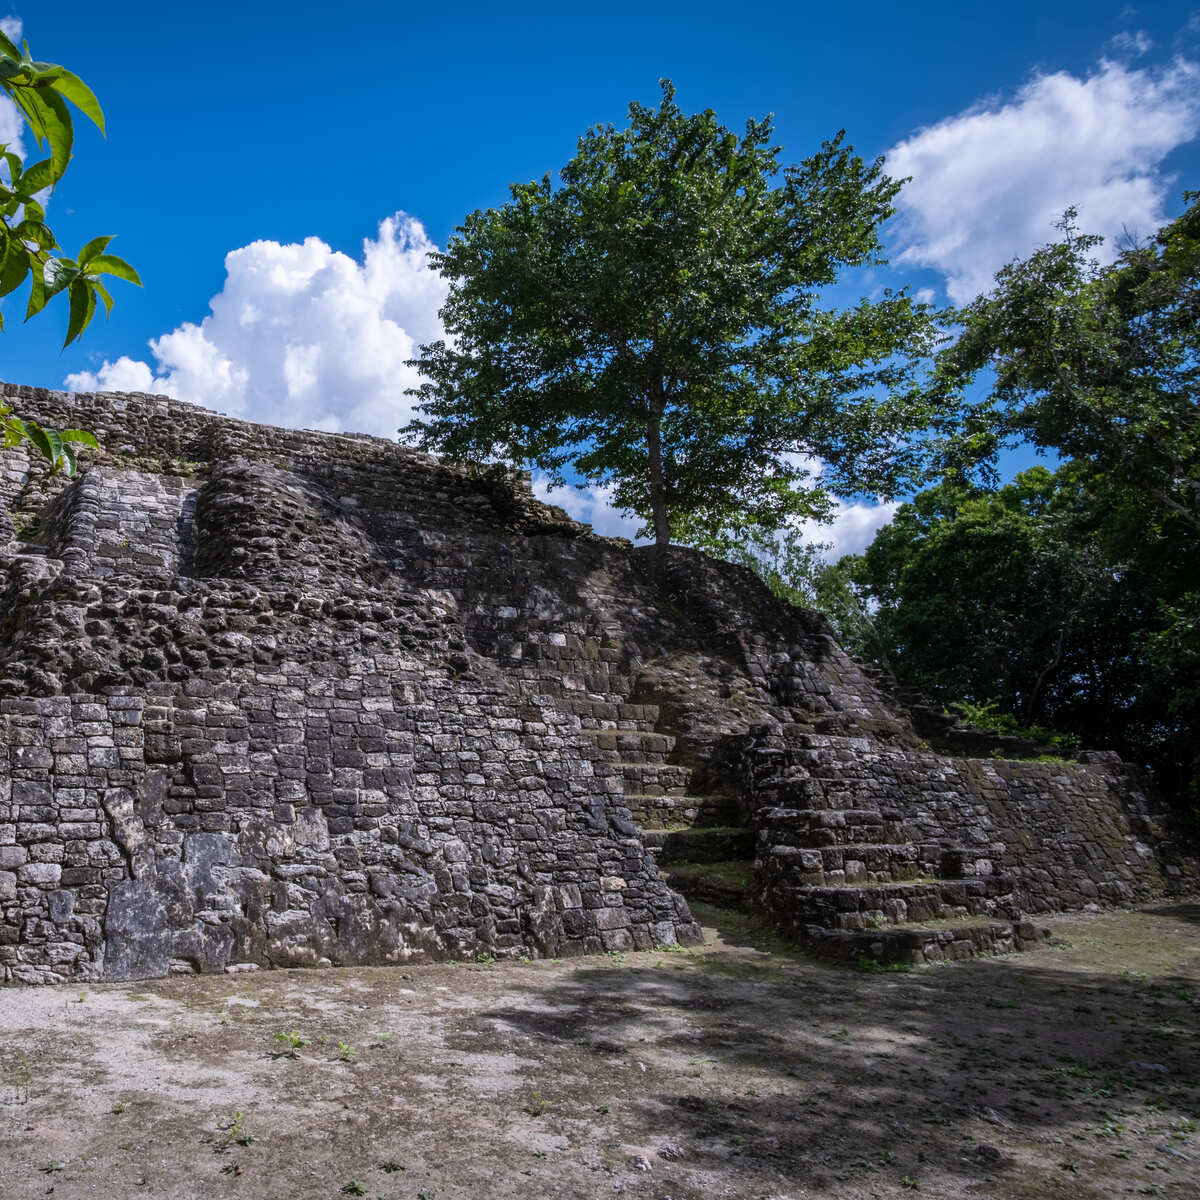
[{"x1": 0, "y1": 0, "x2": 1200, "y2": 548}]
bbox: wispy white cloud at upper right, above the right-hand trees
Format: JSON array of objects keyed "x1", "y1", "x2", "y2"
[{"x1": 887, "y1": 55, "x2": 1200, "y2": 304}]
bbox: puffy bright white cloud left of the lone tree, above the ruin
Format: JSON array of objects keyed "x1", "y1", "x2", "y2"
[{"x1": 66, "y1": 212, "x2": 445, "y2": 437}]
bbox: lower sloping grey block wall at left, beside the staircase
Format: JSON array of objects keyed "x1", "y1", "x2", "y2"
[{"x1": 0, "y1": 655, "x2": 695, "y2": 983}]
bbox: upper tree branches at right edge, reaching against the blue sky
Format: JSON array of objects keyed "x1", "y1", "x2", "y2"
[{"x1": 937, "y1": 192, "x2": 1200, "y2": 533}]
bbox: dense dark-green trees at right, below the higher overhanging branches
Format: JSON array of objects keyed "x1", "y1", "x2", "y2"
[{"x1": 854, "y1": 460, "x2": 1200, "y2": 825}]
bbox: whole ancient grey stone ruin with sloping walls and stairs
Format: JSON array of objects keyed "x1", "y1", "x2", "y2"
[{"x1": 0, "y1": 386, "x2": 1194, "y2": 983}]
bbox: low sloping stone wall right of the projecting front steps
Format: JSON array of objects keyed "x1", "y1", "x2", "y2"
[{"x1": 745, "y1": 728, "x2": 1196, "y2": 913}]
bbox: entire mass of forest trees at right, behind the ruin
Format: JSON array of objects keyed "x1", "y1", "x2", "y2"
[{"x1": 782, "y1": 204, "x2": 1200, "y2": 822}]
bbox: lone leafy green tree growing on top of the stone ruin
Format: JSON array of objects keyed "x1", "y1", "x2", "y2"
[{"x1": 402, "y1": 80, "x2": 936, "y2": 548}]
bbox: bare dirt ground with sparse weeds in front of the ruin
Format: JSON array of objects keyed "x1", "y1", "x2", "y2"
[{"x1": 0, "y1": 904, "x2": 1200, "y2": 1200}]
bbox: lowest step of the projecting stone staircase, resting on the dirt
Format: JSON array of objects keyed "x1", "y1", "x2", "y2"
[{"x1": 793, "y1": 918, "x2": 1050, "y2": 970}]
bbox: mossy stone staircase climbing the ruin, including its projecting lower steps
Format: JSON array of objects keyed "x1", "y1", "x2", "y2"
[{"x1": 398, "y1": 549, "x2": 1042, "y2": 965}]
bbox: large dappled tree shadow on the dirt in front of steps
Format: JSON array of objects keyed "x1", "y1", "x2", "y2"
[{"x1": 465, "y1": 905, "x2": 1200, "y2": 1196}]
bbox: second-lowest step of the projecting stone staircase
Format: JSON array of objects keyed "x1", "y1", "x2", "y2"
[{"x1": 762, "y1": 870, "x2": 1018, "y2": 929}]
